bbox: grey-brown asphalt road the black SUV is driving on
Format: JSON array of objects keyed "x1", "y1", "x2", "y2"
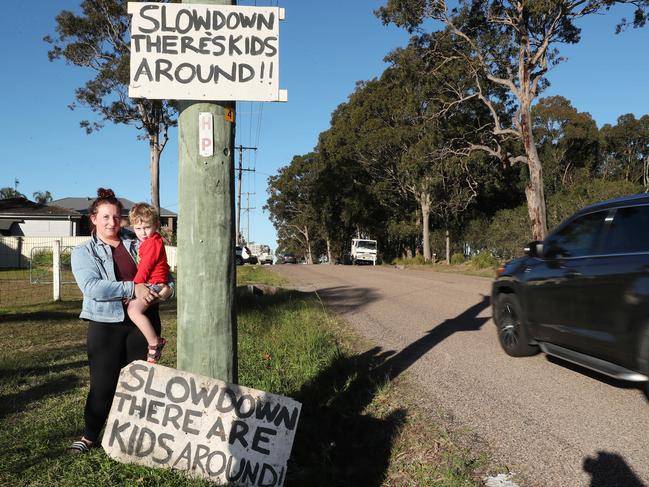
[{"x1": 274, "y1": 265, "x2": 649, "y2": 487}]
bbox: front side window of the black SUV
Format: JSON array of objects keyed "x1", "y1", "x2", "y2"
[{"x1": 543, "y1": 211, "x2": 608, "y2": 259}]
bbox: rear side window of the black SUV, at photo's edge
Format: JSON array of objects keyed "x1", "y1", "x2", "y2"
[{"x1": 602, "y1": 206, "x2": 649, "y2": 254}]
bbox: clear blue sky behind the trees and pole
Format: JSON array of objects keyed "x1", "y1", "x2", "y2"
[{"x1": 0, "y1": 0, "x2": 649, "y2": 249}]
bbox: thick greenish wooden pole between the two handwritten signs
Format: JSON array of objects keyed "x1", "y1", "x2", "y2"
[{"x1": 177, "y1": 0, "x2": 238, "y2": 383}]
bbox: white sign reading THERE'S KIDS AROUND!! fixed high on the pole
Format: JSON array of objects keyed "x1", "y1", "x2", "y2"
[{"x1": 128, "y1": 2, "x2": 286, "y2": 101}]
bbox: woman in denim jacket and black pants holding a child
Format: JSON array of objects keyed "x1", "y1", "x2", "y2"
[{"x1": 68, "y1": 188, "x2": 173, "y2": 453}]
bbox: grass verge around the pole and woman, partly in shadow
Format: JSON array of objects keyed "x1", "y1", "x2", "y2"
[{"x1": 0, "y1": 266, "x2": 487, "y2": 487}]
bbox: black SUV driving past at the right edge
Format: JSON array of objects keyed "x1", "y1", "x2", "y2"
[{"x1": 492, "y1": 194, "x2": 649, "y2": 393}]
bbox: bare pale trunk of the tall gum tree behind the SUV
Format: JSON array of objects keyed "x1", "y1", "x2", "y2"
[{"x1": 520, "y1": 96, "x2": 548, "y2": 240}]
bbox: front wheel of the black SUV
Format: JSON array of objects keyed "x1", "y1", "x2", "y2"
[{"x1": 495, "y1": 294, "x2": 539, "y2": 357}]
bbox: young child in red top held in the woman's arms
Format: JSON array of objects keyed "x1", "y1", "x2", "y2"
[{"x1": 127, "y1": 203, "x2": 169, "y2": 364}]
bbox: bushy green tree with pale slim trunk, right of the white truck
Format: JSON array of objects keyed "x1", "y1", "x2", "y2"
[{"x1": 334, "y1": 36, "x2": 478, "y2": 260}]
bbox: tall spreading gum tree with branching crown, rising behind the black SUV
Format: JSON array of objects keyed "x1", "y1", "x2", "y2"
[{"x1": 377, "y1": 0, "x2": 649, "y2": 239}]
